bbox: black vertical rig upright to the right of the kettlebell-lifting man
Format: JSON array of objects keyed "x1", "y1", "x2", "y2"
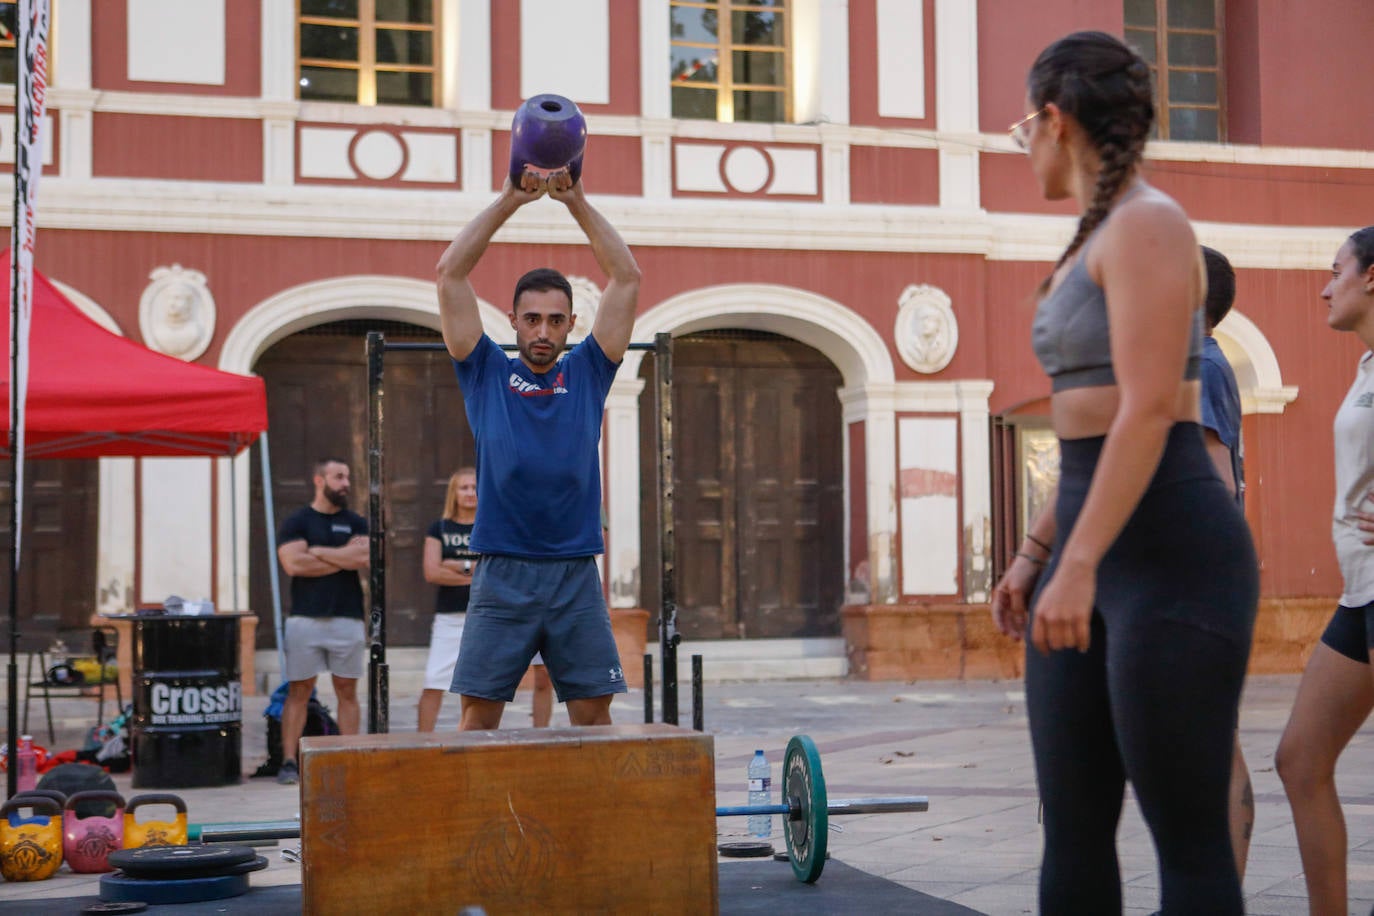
[{"x1": 646, "y1": 332, "x2": 682, "y2": 725}]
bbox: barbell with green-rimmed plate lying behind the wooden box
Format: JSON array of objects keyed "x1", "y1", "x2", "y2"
[{"x1": 187, "y1": 735, "x2": 930, "y2": 884}]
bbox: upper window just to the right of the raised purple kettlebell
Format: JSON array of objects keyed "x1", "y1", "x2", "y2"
[{"x1": 669, "y1": 0, "x2": 791, "y2": 122}]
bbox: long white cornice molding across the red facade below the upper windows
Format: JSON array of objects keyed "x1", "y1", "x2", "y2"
[{"x1": 24, "y1": 176, "x2": 1351, "y2": 271}]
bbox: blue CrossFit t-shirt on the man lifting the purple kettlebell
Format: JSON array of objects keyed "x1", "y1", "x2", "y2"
[{"x1": 453, "y1": 334, "x2": 620, "y2": 559}]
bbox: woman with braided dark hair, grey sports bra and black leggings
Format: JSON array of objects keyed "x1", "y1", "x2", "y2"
[{"x1": 993, "y1": 32, "x2": 1259, "y2": 915}]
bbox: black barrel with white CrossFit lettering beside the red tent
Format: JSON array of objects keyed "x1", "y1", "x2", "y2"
[{"x1": 133, "y1": 614, "x2": 243, "y2": 788}]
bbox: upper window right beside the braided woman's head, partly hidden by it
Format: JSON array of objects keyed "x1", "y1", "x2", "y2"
[{"x1": 1125, "y1": 0, "x2": 1226, "y2": 141}]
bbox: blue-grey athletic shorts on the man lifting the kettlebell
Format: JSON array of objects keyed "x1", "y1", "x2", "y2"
[{"x1": 451, "y1": 556, "x2": 628, "y2": 703}]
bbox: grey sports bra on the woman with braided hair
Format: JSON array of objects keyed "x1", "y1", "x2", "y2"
[{"x1": 1031, "y1": 240, "x2": 1202, "y2": 391}]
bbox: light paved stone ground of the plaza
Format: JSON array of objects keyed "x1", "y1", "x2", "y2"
[{"x1": 0, "y1": 677, "x2": 1374, "y2": 916}]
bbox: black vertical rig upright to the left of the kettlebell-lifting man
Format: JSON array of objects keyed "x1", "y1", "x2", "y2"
[{"x1": 367, "y1": 331, "x2": 392, "y2": 735}]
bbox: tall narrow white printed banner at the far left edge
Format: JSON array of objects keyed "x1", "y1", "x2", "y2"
[{"x1": 10, "y1": 0, "x2": 51, "y2": 565}]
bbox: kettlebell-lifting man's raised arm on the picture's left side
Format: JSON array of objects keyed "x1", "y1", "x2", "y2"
[{"x1": 436, "y1": 174, "x2": 544, "y2": 360}]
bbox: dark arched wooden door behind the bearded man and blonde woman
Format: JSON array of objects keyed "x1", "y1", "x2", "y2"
[{"x1": 250, "y1": 321, "x2": 474, "y2": 648}]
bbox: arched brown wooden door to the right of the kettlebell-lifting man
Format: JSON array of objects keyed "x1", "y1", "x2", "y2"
[{"x1": 640, "y1": 331, "x2": 845, "y2": 639}]
